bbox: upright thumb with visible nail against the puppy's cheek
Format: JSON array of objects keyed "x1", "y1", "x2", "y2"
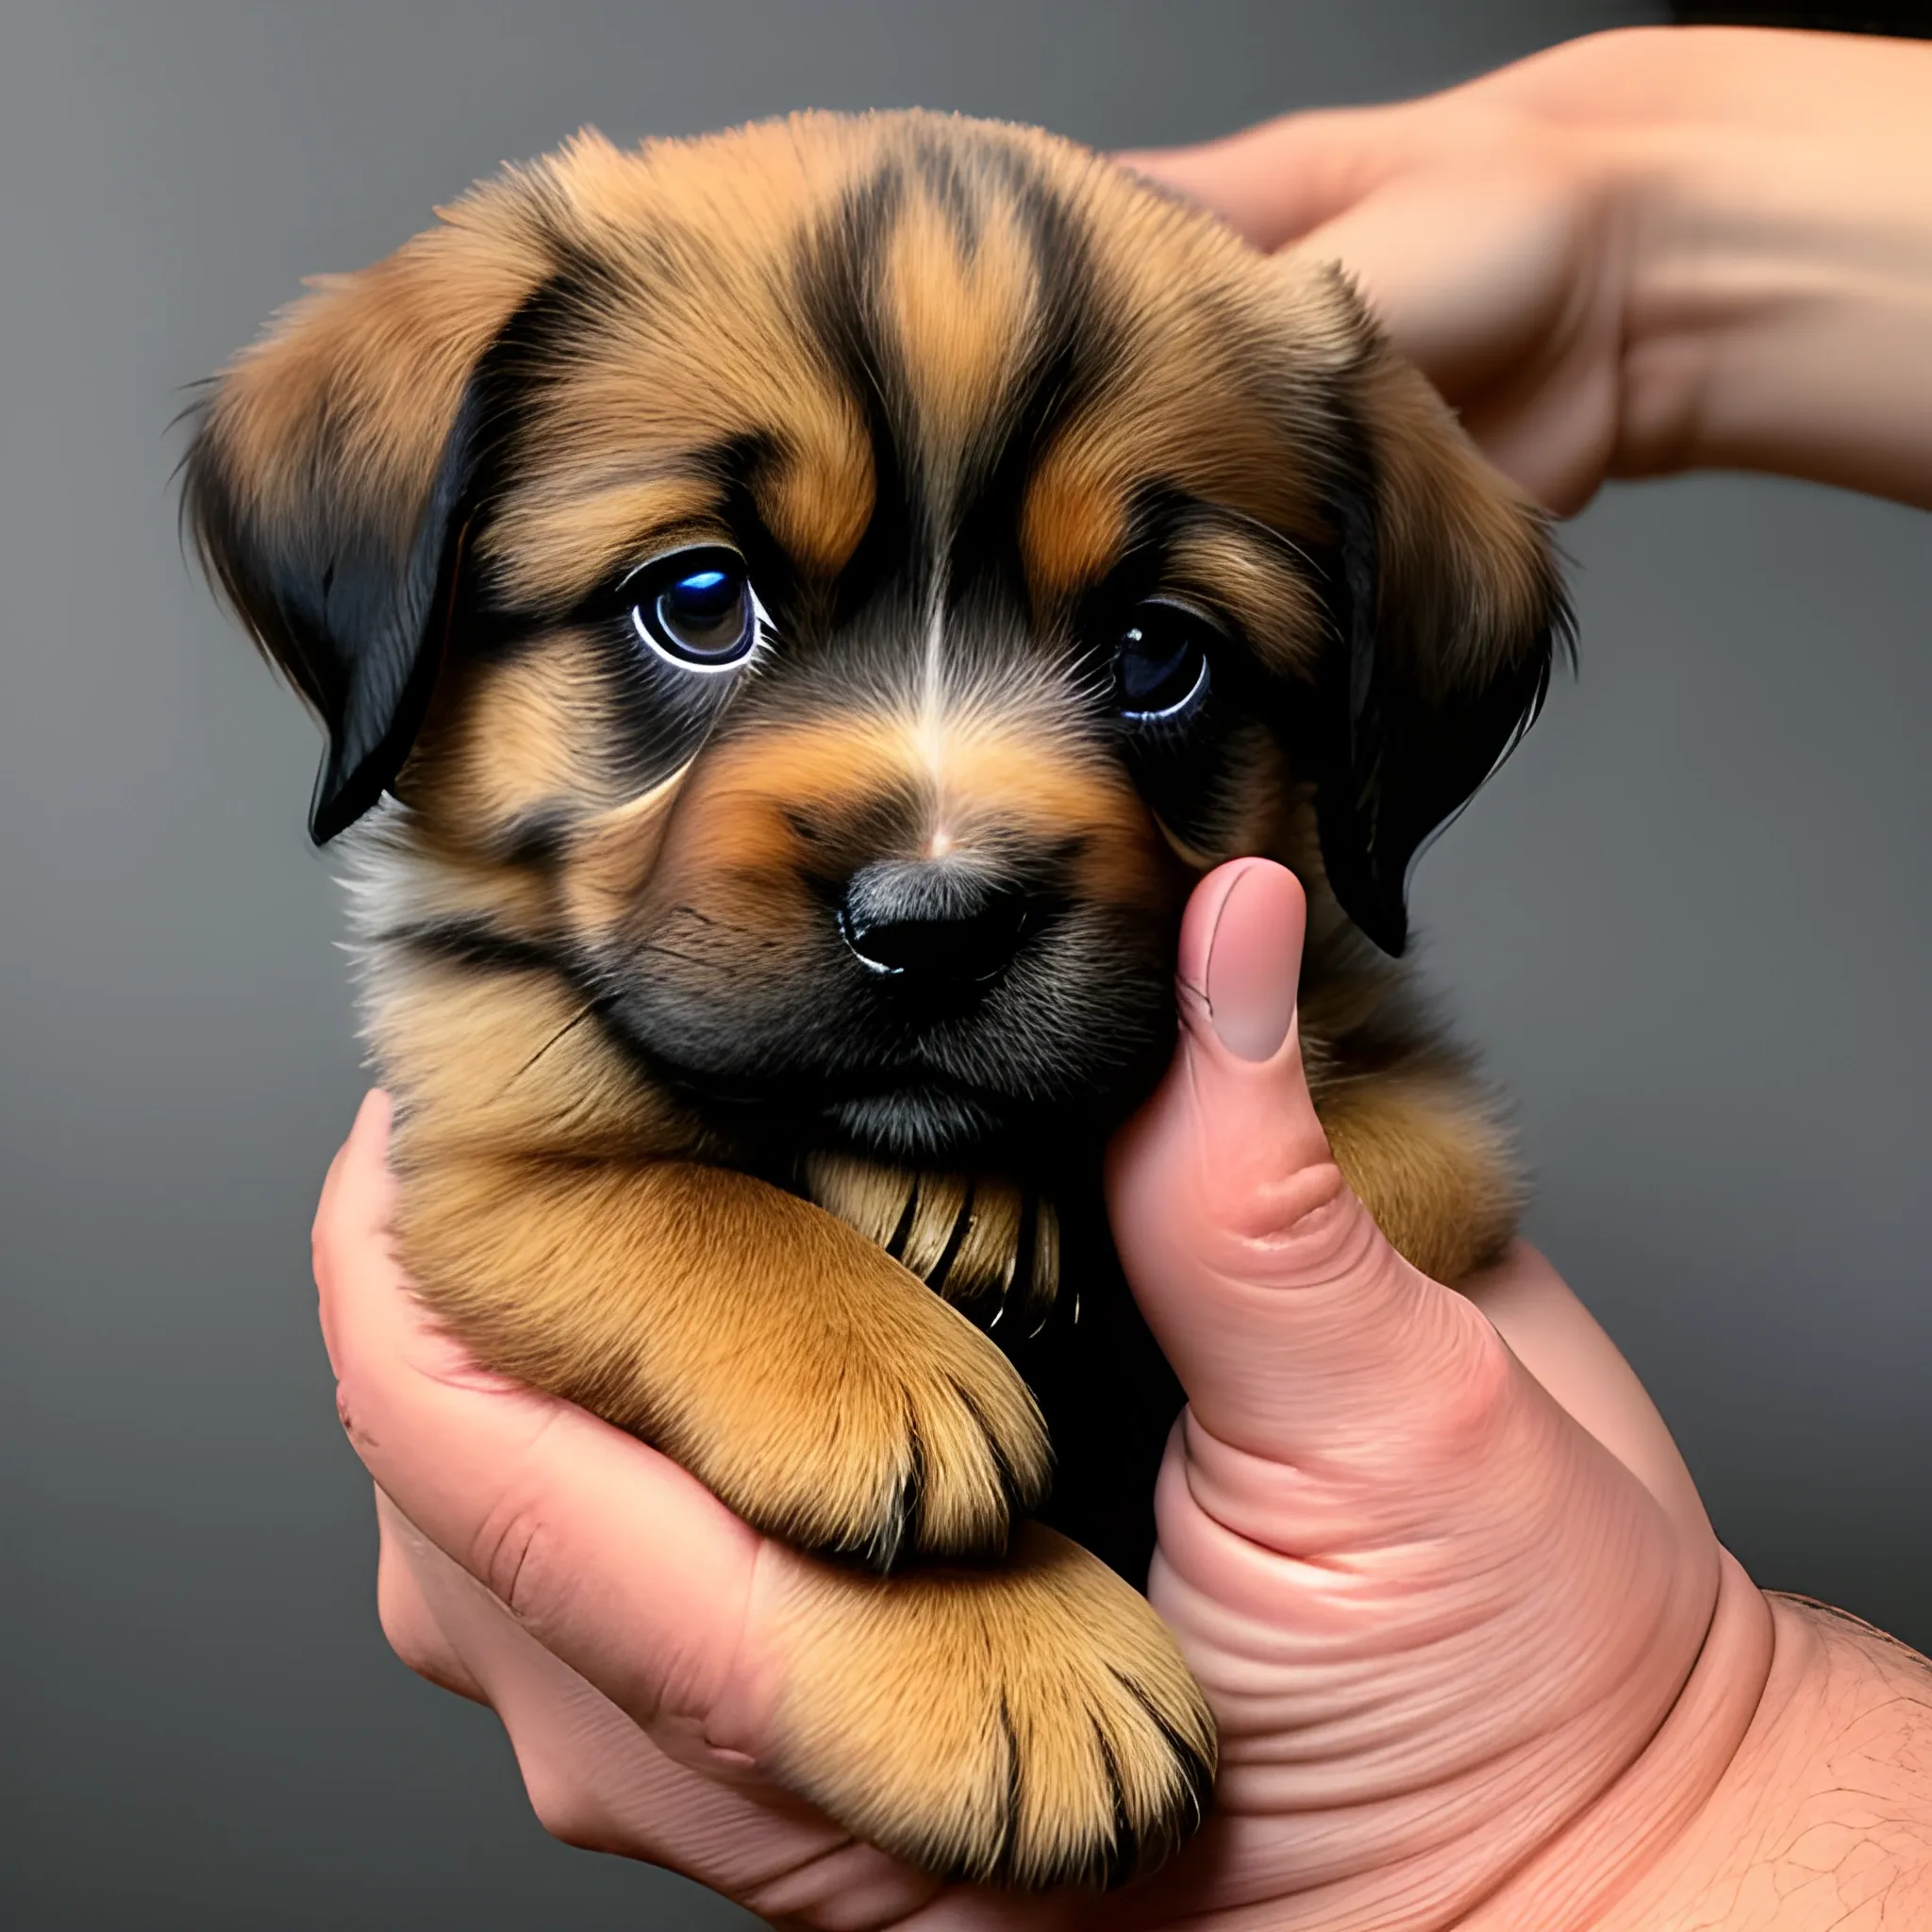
[{"x1": 1108, "y1": 859, "x2": 1508, "y2": 1478}]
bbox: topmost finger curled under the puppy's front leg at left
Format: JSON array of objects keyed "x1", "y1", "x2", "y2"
[{"x1": 317, "y1": 1105, "x2": 778, "y2": 1762}]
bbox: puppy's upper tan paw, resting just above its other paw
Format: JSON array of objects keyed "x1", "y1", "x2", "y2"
[{"x1": 658, "y1": 1250, "x2": 1051, "y2": 1571}]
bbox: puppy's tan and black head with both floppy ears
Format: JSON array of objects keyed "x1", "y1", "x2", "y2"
[{"x1": 188, "y1": 114, "x2": 1563, "y2": 1163}]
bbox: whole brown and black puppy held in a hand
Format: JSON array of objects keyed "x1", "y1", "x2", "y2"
[{"x1": 188, "y1": 114, "x2": 1563, "y2": 1884}]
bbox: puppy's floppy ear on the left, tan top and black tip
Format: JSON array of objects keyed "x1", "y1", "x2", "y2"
[{"x1": 184, "y1": 195, "x2": 542, "y2": 844}]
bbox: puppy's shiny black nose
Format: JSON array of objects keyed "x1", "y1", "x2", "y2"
[{"x1": 839, "y1": 859, "x2": 1034, "y2": 988}]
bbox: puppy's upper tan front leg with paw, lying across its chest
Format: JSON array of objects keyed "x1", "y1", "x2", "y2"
[{"x1": 400, "y1": 1156, "x2": 1049, "y2": 1571}]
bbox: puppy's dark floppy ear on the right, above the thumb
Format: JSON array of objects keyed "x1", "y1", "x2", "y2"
[{"x1": 1310, "y1": 271, "x2": 1571, "y2": 955}]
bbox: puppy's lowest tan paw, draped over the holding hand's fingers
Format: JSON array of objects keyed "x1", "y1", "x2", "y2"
[{"x1": 778, "y1": 1524, "x2": 1215, "y2": 1888}]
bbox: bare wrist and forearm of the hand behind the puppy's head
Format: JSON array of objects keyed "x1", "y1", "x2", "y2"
[{"x1": 1545, "y1": 29, "x2": 1932, "y2": 508}]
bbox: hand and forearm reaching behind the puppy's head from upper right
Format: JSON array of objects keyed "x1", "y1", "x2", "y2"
[{"x1": 1123, "y1": 29, "x2": 1932, "y2": 514}]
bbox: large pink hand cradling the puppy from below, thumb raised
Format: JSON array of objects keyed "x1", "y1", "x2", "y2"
[{"x1": 317, "y1": 859, "x2": 1932, "y2": 1932}]
